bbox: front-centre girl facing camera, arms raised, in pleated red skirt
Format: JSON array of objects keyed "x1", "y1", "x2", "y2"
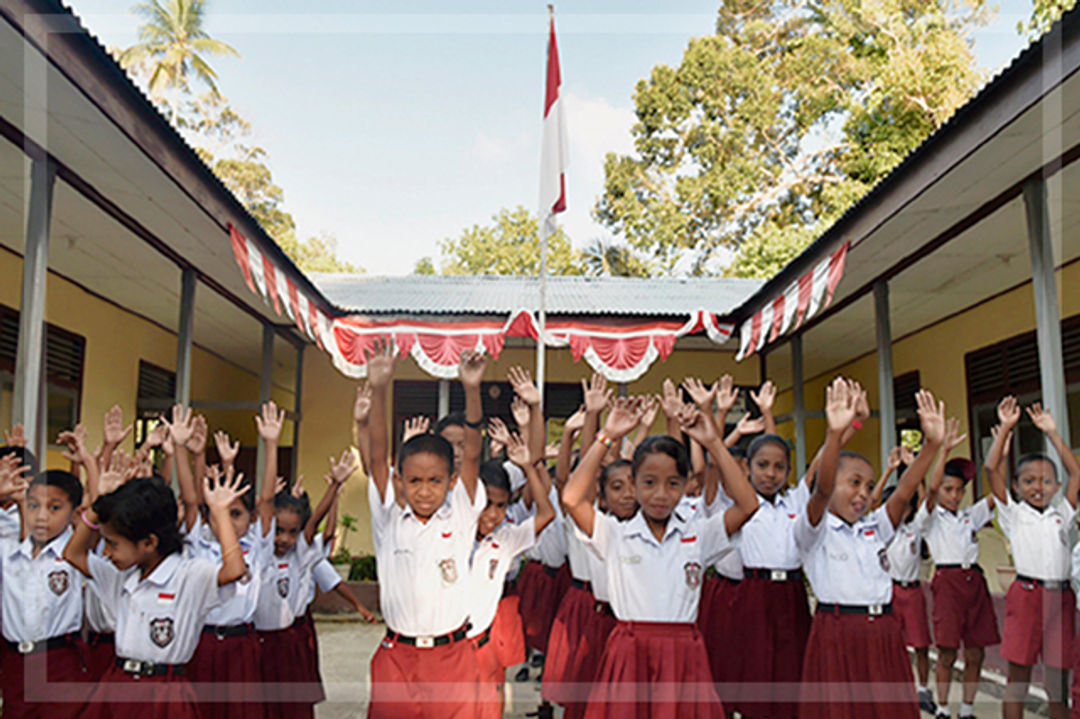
[{"x1": 563, "y1": 397, "x2": 756, "y2": 719}]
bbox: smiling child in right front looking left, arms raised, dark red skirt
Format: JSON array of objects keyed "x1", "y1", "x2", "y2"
[{"x1": 795, "y1": 378, "x2": 945, "y2": 719}]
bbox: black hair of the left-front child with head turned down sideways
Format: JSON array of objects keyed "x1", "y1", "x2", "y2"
[{"x1": 93, "y1": 477, "x2": 184, "y2": 557}]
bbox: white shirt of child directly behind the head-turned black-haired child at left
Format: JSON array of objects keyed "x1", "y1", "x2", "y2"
[{"x1": 184, "y1": 516, "x2": 273, "y2": 626}]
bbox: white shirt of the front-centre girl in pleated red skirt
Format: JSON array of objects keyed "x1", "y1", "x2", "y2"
[{"x1": 577, "y1": 510, "x2": 738, "y2": 623}]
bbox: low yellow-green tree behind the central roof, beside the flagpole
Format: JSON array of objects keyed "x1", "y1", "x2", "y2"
[{"x1": 434, "y1": 205, "x2": 581, "y2": 275}]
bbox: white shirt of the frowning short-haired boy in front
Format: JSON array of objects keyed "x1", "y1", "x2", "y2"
[{"x1": 367, "y1": 480, "x2": 487, "y2": 637}]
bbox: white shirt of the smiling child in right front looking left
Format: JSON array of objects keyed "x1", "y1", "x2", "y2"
[{"x1": 795, "y1": 505, "x2": 895, "y2": 607}]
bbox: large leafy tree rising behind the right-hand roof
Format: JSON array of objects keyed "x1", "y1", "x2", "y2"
[{"x1": 594, "y1": 0, "x2": 988, "y2": 276}]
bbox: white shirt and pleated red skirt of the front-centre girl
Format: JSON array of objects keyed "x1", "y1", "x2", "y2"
[{"x1": 579, "y1": 511, "x2": 735, "y2": 719}]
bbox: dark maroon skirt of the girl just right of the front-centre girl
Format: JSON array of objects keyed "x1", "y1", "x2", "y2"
[{"x1": 725, "y1": 569, "x2": 810, "y2": 719}]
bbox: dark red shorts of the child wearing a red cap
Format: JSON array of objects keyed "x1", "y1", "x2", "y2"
[{"x1": 930, "y1": 568, "x2": 1001, "y2": 649}]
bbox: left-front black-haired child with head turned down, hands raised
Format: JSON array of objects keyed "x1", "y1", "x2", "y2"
[{"x1": 64, "y1": 473, "x2": 249, "y2": 719}]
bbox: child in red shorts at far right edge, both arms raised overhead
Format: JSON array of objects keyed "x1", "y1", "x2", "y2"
[{"x1": 986, "y1": 397, "x2": 1080, "y2": 719}]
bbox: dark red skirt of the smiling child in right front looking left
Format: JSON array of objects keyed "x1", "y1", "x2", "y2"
[{"x1": 798, "y1": 612, "x2": 919, "y2": 719}]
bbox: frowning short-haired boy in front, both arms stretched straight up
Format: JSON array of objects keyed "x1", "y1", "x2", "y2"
[{"x1": 368, "y1": 342, "x2": 487, "y2": 719}]
